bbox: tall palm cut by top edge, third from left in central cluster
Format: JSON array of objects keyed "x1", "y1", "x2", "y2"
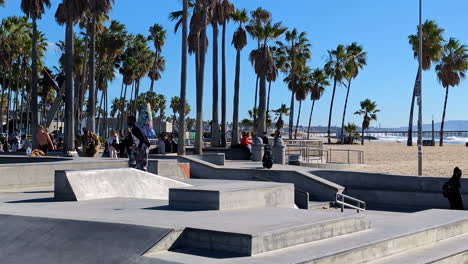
[{"x1": 210, "y1": 0, "x2": 221, "y2": 147}]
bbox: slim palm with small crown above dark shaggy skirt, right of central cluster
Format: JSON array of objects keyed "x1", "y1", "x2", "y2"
[{"x1": 231, "y1": 9, "x2": 249, "y2": 146}]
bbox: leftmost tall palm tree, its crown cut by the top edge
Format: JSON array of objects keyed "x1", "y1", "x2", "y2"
[{"x1": 20, "y1": 0, "x2": 50, "y2": 146}]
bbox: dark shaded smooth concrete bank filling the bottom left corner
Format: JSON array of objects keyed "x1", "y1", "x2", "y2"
[{"x1": 0, "y1": 215, "x2": 171, "y2": 264}]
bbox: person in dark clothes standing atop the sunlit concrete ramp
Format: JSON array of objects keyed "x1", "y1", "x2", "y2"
[{"x1": 127, "y1": 116, "x2": 151, "y2": 171}]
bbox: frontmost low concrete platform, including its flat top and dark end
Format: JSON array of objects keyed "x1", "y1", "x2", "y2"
[{"x1": 147, "y1": 208, "x2": 370, "y2": 256}]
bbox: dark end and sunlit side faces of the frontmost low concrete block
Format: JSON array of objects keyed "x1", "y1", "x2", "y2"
[{"x1": 165, "y1": 209, "x2": 370, "y2": 256}]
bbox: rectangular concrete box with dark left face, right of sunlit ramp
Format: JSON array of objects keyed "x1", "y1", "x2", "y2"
[{"x1": 169, "y1": 181, "x2": 294, "y2": 210}]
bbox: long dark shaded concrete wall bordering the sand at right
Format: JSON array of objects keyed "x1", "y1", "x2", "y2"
[{"x1": 311, "y1": 170, "x2": 468, "y2": 210}]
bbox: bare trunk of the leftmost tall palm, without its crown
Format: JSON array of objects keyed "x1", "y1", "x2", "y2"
[{"x1": 30, "y1": 17, "x2": 39, "y2": 148}]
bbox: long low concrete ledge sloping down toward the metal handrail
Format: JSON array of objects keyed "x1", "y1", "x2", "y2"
[{"x1": 154, "y1": 156, "x2": 344, "y2": 201}]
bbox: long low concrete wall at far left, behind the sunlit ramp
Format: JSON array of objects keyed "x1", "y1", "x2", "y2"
[{"x1": 0, "y1": 158, "x2": 128, "y2": 190}]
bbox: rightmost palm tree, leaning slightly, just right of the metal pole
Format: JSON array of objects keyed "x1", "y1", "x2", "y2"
[{"x1": 436, "y1": 38, "x2": 468, "y2": 147}]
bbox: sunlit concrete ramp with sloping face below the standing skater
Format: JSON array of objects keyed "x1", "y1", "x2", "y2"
[{"x1": 54, "y1": 168, "x2": 191, "y2": 201}]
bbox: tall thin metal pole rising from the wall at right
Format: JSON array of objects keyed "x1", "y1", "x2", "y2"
[{"x1": 417, "y1": 0, "x2": 423, "y2": 176}]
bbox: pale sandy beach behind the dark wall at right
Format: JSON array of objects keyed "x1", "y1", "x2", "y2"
[{"x1": 324, "y1": 141, "x2": 468, "y2": 177}]
